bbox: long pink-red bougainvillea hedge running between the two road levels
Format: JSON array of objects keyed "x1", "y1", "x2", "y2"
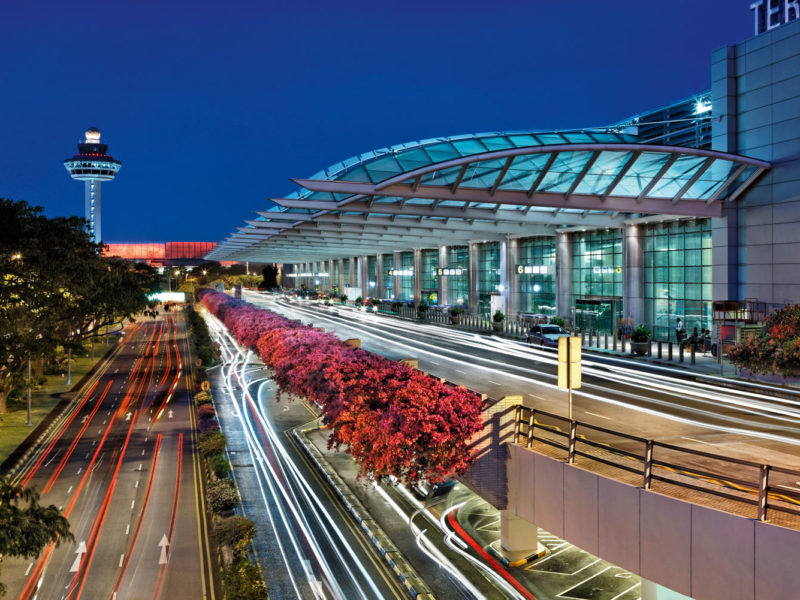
[{"x1": 198, "y1": 289, "x2": 482, "y2": 483}]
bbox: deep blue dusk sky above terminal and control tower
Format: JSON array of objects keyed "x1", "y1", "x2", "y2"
[{"x1": 0, "y1": 0, "x2": 753, "y2": 242}]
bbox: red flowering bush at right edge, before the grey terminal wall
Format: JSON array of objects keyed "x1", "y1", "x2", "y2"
[{"x1": 728, "y1": 304, "x2": 800, "y2": 377}]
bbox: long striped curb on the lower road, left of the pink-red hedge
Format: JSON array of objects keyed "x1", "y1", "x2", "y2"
[{"x1": 292, "y1": 428, "x2": 435, "y2": 600}]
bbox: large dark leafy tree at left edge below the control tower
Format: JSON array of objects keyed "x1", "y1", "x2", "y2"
[{"x1": 0, "y1": 198, "x2": 154, "y2": 413}]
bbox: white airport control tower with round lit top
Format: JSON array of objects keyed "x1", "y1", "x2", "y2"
[{"x1": 64, "y1": 127, "x2": 122, "y2": 242}]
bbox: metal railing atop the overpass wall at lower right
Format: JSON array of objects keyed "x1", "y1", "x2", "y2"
[{"x1": 514, "y1": 406, "x2": 800, "y2": 521}]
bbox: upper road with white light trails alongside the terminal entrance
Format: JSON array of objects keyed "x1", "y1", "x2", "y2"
[{"x1": 246, "y1": 292, "x2": 800, "y2": 468}]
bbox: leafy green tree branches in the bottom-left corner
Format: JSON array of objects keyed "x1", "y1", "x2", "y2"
[{"x1": 0, "y1": 478, "x2": 75, "y2": 596}]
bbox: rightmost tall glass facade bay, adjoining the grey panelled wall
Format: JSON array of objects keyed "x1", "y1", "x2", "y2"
[{"x1": 642, "y1": 219, "x2": 712, "y2": 340}]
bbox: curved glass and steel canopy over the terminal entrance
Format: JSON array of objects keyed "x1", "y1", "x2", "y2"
[{"x1": 206, "y1": 131, "x2": 770, "y2": 263}]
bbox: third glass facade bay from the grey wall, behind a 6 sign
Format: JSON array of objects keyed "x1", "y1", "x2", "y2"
[{"x1": 515, "y1": 237, "x2": 556, "y2": 315}]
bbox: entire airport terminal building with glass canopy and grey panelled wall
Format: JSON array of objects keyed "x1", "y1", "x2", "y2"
[{"x1": 207, "y1": 11, "x2": 800, "y2": 338}]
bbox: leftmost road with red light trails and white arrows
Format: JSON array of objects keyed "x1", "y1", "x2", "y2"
[{"x1": 3, "y1": 313, "x2": 214, "y2": 600}]
